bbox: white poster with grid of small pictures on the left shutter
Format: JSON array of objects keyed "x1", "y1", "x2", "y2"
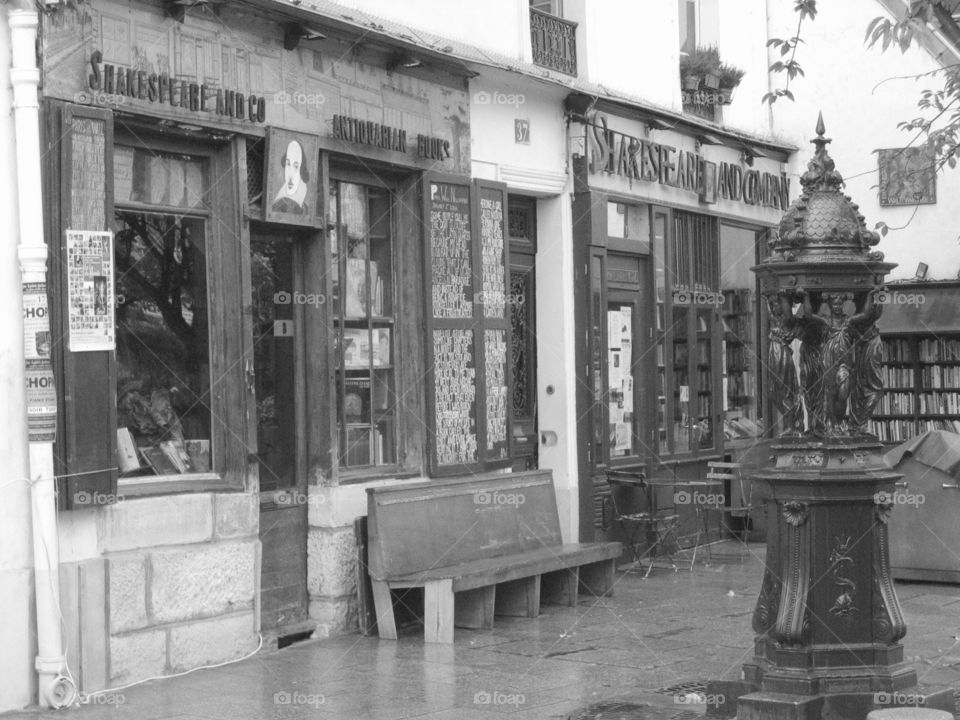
[{"x1": 67, "y1": 230, "x2": 115, "y2": 352}]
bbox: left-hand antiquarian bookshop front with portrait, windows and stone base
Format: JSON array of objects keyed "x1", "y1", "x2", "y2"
[{"x1": 38, "y1": 1, "x2": 511, "y2": 691}]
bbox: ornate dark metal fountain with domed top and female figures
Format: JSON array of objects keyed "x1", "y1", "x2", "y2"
[{"x1": 711, "y1": 116, "x2": 953, "y2": 720}]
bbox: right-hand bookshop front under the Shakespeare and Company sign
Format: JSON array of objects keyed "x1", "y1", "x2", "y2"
[{"x1": 572, "y1": 103, "x2": 791, "y2": 537}]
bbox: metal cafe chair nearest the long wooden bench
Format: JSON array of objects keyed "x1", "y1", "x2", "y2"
[{"x1": 606, "y1": 470, "x2": 680, "y2": 578}]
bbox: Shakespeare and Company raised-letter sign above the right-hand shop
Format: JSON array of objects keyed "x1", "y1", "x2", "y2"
[{"x1": 587, "y1": 116, "x2": 790, "y2": 209}]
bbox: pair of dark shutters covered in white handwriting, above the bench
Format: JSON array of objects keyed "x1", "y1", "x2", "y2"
[{"x1": 423, "y1": 173, "x2": 511, "y2": 476}]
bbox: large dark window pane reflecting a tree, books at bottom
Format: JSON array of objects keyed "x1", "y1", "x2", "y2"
[{"x1": 114, "y1": 211, "x2": 213, "y2": 475}]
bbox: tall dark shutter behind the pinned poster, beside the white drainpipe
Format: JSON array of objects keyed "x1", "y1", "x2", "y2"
[{"x1": 44, "y1": 102, "x2": 117, "y2": 509}]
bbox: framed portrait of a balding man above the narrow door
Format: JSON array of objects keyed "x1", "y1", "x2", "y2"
[{"x1": 263, "y1": 128, "x2": 320, "y2": 226}]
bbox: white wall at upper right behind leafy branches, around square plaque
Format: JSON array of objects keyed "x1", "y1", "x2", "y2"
[{"x1": 770, "y1": 0, "x2": 960, "y2": 279}]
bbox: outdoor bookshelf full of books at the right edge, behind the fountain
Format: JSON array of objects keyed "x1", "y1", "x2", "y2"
[{"x1": 869, "y1": 282, "x2": 960, "y2": 443}]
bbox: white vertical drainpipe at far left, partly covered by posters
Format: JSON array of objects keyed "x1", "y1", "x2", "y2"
[{"x1": 8, "y1": 0, "x2": 76, "y2": 708}]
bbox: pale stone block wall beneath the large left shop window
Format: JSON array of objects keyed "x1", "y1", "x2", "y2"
[{"x1": 97, "y1": 493, "x2": 260, "y2": 685}]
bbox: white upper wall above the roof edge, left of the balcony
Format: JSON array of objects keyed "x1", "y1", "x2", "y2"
[{"x1": 335, "y1": 0, "x2": 530, "y2": 58}]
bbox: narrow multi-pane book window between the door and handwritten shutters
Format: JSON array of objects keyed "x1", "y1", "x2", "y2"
[{"x1": 327, "y1": 181, "x2": 397, "y2": 469}]
